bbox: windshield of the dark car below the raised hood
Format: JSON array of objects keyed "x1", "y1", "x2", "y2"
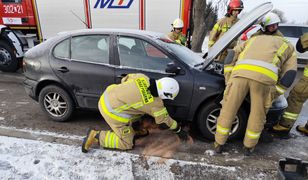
[{"x1": 157, "y1": 39, "x2": 205, "y2": 68}]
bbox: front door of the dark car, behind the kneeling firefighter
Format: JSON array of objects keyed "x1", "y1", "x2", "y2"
[{"x1": 115, "y1": 36, "x2": 193, "y2": 120}]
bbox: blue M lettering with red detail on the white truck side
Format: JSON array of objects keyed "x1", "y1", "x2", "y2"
[{"x1": 94, "y1": 0, "x2": 134, "y2": 9}]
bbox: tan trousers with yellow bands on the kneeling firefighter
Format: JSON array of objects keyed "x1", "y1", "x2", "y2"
[{"x1": 98, "y1": 101, "x2": 135, "y2": 150}]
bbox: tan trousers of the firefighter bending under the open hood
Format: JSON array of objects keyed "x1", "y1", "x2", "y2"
[{"x1": 215, "y1": 77, "x2": 273, "y2": 148}]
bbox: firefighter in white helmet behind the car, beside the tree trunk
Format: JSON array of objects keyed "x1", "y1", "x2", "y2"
[{"x1": 168, "y1": 18, "x2": 186, "y2": 46}]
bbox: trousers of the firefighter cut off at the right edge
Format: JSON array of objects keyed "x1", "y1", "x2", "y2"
[{"x1": 279, "y1": 76, "x2": 308, "y2": 128}]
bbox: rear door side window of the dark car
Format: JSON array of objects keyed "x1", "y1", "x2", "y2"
[{"x1": 71, "y1": 35, "x2": 109, "y2": 63}]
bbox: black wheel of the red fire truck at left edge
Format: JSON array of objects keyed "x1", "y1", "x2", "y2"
[{"x1": 0, "y1": 40, "x2": 18, "y2": 72}]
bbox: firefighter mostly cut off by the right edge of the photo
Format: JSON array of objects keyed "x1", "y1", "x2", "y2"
[{"x1": 273, "y1": 33, "x2": 308, "y2": 137}]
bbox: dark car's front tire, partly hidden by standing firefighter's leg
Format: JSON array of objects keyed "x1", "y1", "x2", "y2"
[{"x1": 197, "y1": 101, "x2": 247, "y2": 141}]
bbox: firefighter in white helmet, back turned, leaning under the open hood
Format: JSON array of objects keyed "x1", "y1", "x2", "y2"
[{"x1": 214, "y1": 14, "x2": 297, "y2": 155}]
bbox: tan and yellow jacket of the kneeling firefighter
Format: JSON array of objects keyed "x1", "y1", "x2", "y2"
[{"x1": 100, "y1": 74, "x2": 177, "y2": 130}]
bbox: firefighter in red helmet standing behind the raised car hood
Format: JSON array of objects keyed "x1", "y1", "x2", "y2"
[{"x1": 208, "y1": 0, "x2": 244, "y2": 61}]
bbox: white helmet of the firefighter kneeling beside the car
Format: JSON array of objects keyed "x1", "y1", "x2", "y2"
[{"x1": 156, "y1": 77, "x2": 180, "y2": 100}]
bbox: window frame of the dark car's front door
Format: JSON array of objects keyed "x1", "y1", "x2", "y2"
[{"x1": 114, "y1": 33, "x2": 178, "y2": 75}]
